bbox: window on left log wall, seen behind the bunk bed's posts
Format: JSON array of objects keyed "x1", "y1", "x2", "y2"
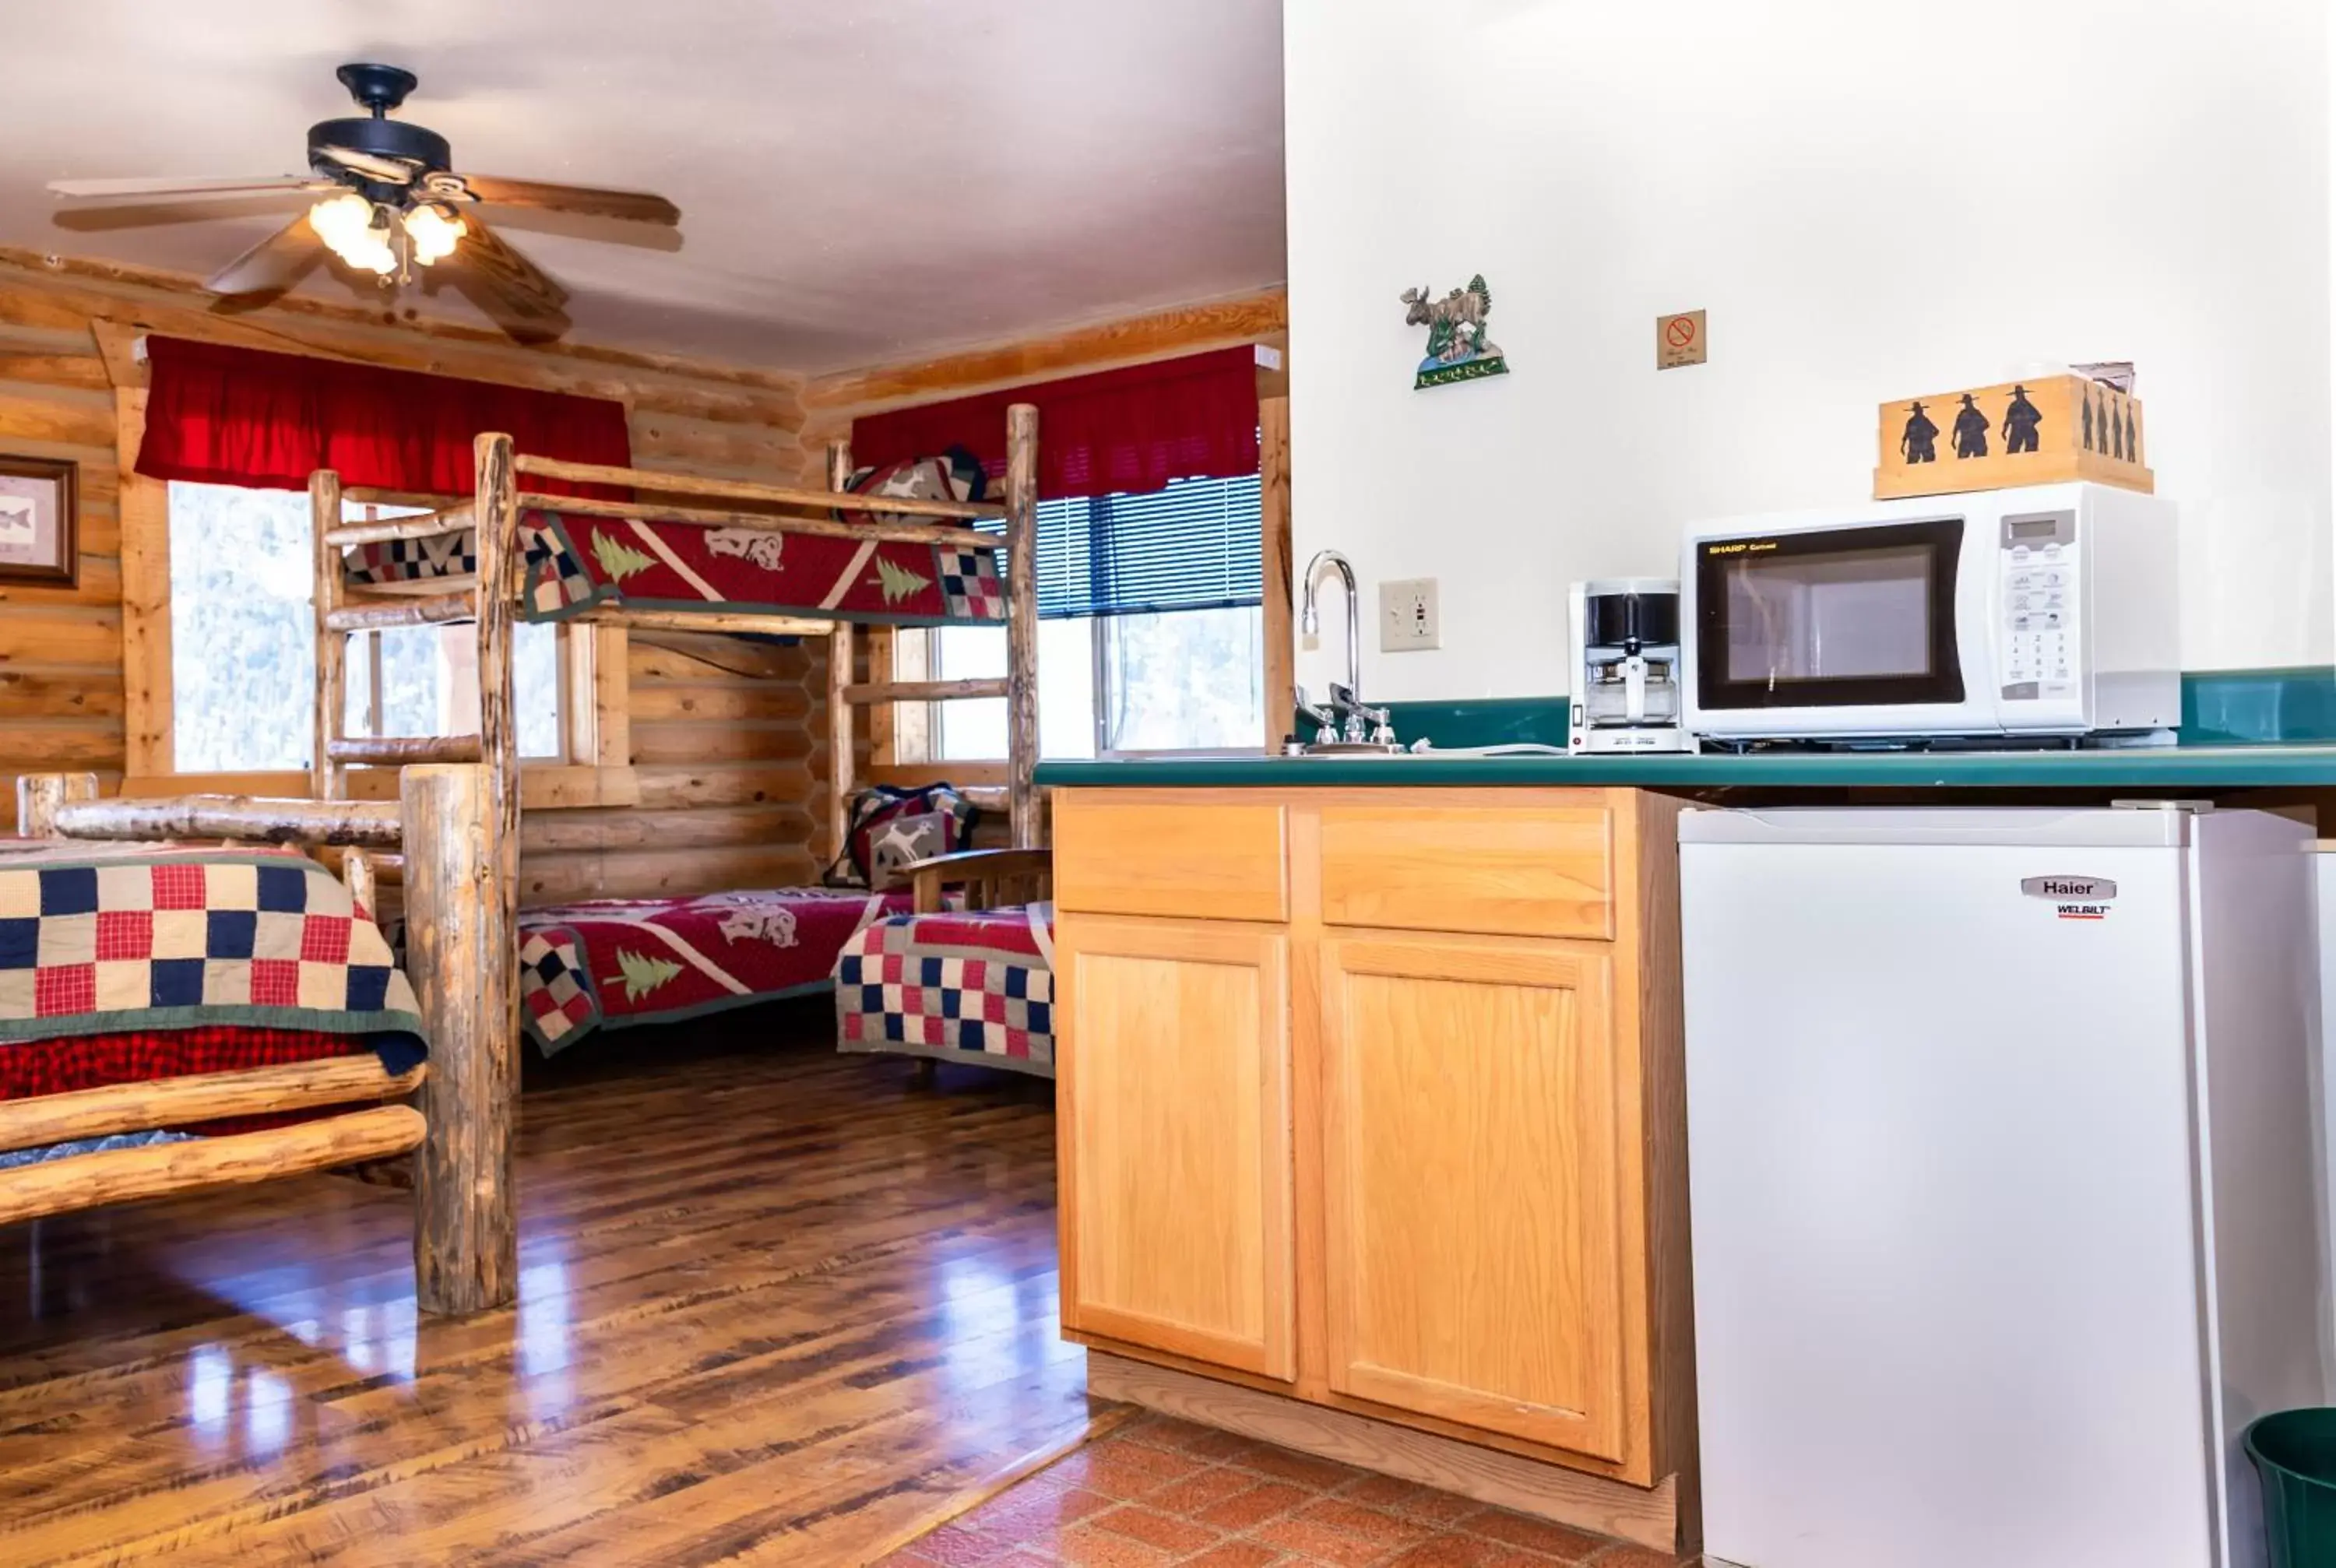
[{"x1": 171, "y1": 481, "x2": 563, "y2": 773}]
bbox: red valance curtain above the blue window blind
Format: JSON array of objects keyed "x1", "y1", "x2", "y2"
[{"x1": 853, "y1": 346, "x2": 1257, "y2": 500}]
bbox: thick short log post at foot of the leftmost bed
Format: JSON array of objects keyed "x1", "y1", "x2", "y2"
[{"x1": 399, "y1": 766, "x2": 519, "y2": 1316}]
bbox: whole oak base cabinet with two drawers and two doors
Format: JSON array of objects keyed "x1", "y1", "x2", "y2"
[{"x1": 1054, "y1": 785, "x2": 1694, "y2": 1524}]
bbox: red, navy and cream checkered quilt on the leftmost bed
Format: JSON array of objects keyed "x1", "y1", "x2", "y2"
[{"x1": 0, "y1": 844, "x2": 423, "y2": 1066}]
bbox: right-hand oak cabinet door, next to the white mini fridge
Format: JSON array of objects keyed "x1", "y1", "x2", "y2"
[{"x1": 1322, "y1": 937, "x2": 1626, "y2": 1463}]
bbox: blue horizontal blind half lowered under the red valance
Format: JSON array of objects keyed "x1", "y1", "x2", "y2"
[{"x1": 981, "y1": 474, "x2": 1264, "y2": 621}]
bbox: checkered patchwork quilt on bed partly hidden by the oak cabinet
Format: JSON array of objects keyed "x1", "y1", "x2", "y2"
[{"x1": 836, "y1": 905, "x2": 1054, "y2": 1078}]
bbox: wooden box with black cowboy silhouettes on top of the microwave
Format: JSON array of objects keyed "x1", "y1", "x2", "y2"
[{"x1": 1873, "y1": 376, "x2": 2156, "y2": 500}]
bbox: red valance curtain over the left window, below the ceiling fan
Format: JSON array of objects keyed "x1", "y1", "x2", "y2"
[{"x1": 138, "y1": 336, "x2": 633, "y2": 495}]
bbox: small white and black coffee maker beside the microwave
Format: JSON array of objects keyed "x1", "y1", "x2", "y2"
[{"x1": 1565, "y1": 577, "x2": 1694, "y2": 754}]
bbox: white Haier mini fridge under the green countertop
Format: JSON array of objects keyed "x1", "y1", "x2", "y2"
[{"x1": 1680, "y1": 807, "x2": 2329, "y2": 1568}]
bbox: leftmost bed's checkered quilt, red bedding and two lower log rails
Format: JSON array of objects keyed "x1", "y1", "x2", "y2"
[{"x1": 0, "y1": 842, "x2": 425, "y2": 1222}]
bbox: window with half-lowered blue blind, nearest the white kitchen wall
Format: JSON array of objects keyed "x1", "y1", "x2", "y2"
[{"x1": 932, "y1": 476, "x2": 1264, "y2": 761}]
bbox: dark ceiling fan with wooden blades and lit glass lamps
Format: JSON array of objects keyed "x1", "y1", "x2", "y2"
[{"x1": 49, "y1": 63, "x2": 682, "y2": 341}]
